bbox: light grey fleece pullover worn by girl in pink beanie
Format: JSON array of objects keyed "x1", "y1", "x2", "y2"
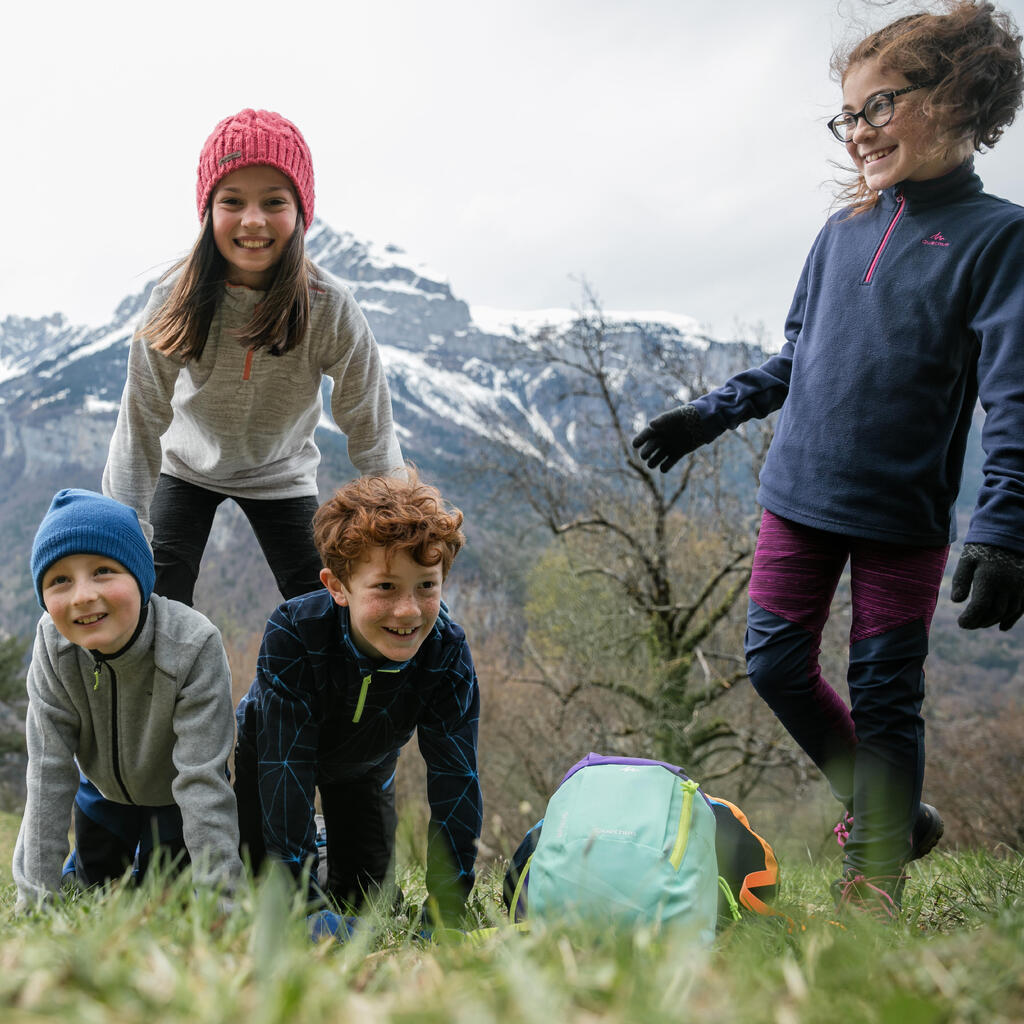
[{"x1": 102, "y1": 267, "x2": 402, "y2": 540}]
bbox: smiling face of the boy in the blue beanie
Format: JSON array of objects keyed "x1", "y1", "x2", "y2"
[{"x1": 42, "y1": 555, "x2": 142, "y2": 654}]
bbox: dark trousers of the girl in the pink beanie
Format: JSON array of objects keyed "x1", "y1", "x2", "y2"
[{"x1": 150, "y1": 473, "x2": 323, "y2": 606}]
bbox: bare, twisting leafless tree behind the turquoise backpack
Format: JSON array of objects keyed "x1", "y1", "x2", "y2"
[{"x1": 474, "y1": 287, "x2": 792, "y2": 776}]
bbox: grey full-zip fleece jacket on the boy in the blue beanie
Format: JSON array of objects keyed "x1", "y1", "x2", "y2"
[{"x1": 12, "y1": 596, "x2": 242, "y2": 907}]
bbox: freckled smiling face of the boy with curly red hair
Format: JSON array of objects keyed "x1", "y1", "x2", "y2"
[{"x1": 321, "y1": 547, "x2": 442, "y2": 662}]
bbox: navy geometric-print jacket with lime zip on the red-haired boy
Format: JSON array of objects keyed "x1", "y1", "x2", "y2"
[{"x1": 236, "y1": 590, "x2": 483, "y2": 902}]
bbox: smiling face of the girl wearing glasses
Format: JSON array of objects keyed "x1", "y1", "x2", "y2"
[{"x1": 843, "y1": 58, "x2": 971, "y2": 191}]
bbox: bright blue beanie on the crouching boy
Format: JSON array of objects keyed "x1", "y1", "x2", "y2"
[{"x1": 32, "y1": 487, "x2": 157, "y2": 608}]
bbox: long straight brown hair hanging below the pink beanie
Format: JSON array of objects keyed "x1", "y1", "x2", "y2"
[{"x1": 136, "y1": 209, "x2": 317, "y2": 362}]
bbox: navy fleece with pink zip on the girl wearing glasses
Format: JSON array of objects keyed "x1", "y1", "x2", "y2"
[{"x1": 693, "y1": 162, "x2": 1024, "y2": 553}]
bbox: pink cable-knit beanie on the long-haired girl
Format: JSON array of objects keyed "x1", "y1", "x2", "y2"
[{"x1": 196, "y1": 110, "x2": 313, "y2": 230}]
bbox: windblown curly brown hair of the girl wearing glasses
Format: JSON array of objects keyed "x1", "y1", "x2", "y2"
[{"x1": 831, "y1": 0, "x2": 1024, "y2": 213}]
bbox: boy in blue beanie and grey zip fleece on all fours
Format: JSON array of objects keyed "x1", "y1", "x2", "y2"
[{"x1": 13, "y1": 488, "x2": 242, "y2": 908}]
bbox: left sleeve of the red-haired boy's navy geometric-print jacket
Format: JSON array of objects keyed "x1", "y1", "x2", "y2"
[{"x1": 255, "y1": 606, "x2": 319, "y2": 879}]
